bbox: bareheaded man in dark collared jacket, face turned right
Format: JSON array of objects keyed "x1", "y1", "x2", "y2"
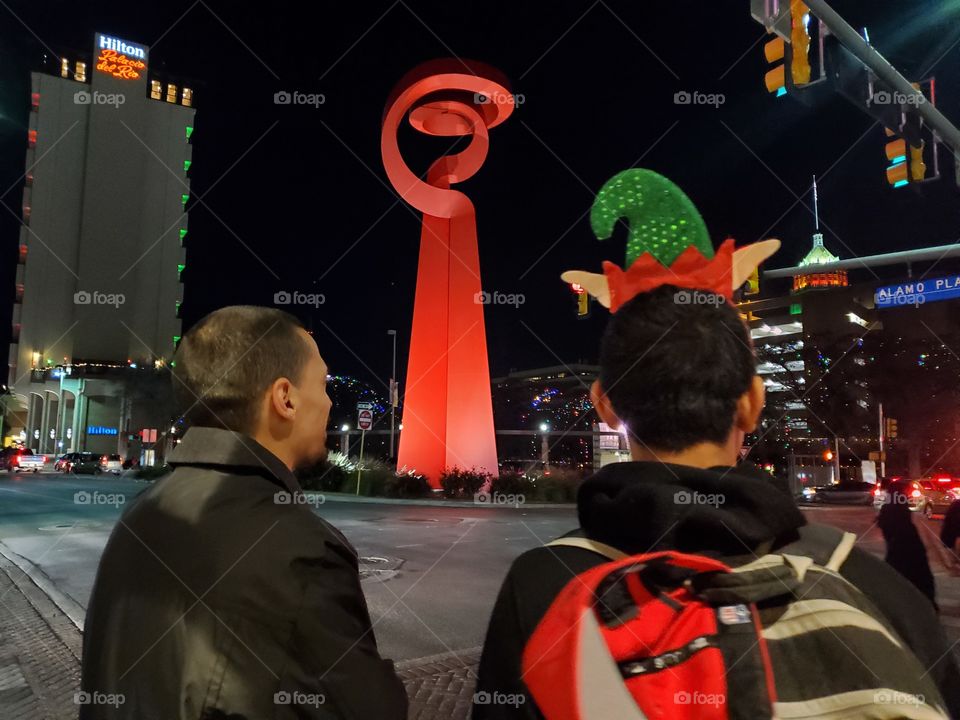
[{"x1": 79, "y1": 307, "x2": 407, "y2": 720}]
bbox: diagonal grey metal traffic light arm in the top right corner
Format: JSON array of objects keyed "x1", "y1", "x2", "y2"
[{"x1": 805, "y1": 0, "x2": 960, "y2": 158}]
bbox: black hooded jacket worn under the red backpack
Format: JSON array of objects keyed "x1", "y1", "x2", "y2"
[{"x1": 473, "y1": 462, "x2": 960, "y2": 720}]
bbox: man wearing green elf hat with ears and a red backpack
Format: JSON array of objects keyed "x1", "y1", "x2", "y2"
[{"x1": 472, "y1": 169, "x2": 960, "y2": 720}]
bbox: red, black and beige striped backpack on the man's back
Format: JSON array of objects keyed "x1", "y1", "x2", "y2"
[{"x1": 522, "y1": 526, "x2": 948, "y2": 720}]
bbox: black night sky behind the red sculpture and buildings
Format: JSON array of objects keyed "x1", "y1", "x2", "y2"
[{"x1": 0, "y1": 0, "x2": 960, "y2": 388}]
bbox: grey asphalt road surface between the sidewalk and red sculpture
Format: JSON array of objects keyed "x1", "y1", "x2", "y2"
[{"x1": 0, "y1": 474, "x2": 928, "y2": 660}]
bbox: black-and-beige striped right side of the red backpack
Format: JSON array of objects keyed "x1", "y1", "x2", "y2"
[{"x1": 728, "y1": 525, "x2": 948, "y2": 720}]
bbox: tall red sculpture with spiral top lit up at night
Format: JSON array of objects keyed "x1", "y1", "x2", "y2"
[{"x1": 380, "y1": 59, "x2": 514, "y2": 486}]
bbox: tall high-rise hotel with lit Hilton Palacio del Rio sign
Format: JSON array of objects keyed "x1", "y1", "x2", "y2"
[{"x1": 8, "y1": 33, "x2": 195, "y2": 453}]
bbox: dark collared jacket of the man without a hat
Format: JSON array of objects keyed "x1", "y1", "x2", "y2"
[{"x1": 80, "y1": 428, "x2": 407, "y2": 720}]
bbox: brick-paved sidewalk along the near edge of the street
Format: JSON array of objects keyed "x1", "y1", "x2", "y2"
[{"x1": 0, "y1": 518, "x2": 960, "y2": 720}]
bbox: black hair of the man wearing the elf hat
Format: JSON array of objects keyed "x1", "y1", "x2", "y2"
[{"x1": 600, "y1": 285, "x2": 756, "y2": 452}]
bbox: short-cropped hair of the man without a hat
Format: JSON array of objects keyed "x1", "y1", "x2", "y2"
[{"x1": 173, "y1": 305, "x2": 309, "y2": 434}]
